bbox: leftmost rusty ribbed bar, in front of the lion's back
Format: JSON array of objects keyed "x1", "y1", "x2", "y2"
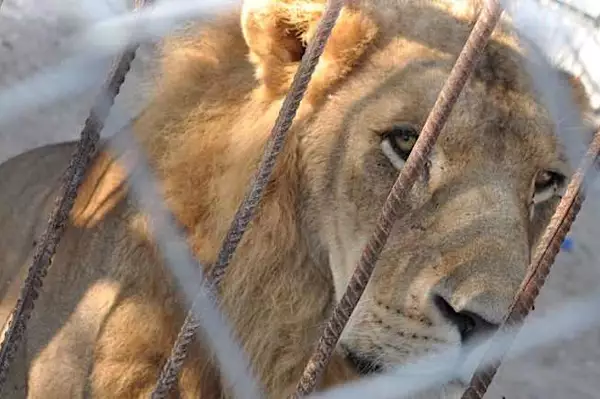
[{"x1": 0, "y1": 0, "x2": 149, "y2": 390}]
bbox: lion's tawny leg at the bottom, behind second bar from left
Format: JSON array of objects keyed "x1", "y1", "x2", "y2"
[{"x1": 90, "y1": 296, "x2": 220, "y2": 399}]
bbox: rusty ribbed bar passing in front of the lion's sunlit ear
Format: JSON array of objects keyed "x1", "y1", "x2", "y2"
[{"x1": 152, "y1": 0, "x2": 344, "y2": 399}]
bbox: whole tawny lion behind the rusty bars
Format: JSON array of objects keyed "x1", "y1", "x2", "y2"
[{"x1": 0, "y1": 0, "x2": 588, "y2": 398}]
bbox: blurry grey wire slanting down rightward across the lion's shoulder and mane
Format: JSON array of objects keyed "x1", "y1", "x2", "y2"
[{"x1": 105, "y1": 120, "x2": 262, "y2": 399}]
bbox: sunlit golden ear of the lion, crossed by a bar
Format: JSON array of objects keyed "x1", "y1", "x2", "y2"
[{"x1": 241, "y1": 0, "x2": 377, "y2": 100}]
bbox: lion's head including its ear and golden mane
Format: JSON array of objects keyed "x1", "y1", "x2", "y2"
[{"x1": 127, "y1": 0, "x2": 596, "y2": 397}]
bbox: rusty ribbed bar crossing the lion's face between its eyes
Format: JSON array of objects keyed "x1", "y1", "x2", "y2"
[{"x1": 292, "y1": 0, "x2": 502, "y2": 398}]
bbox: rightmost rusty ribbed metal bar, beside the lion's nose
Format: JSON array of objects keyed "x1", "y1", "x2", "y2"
[{"x1": 462, "y1": 131, "x2": 600, "y2": 399}]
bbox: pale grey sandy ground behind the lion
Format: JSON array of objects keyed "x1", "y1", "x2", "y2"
[{"x1": 0, "y1": 0, "x2": 600, "y2": 399}]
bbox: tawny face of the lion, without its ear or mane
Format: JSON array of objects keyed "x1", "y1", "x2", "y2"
[{"x1": 306, "y1": 55, "x2": 571, "y2": 384}]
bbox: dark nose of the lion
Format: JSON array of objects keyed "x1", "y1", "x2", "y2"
[{"x1": 433, "y1": 295, "x2": 498, "y2": 344}]
